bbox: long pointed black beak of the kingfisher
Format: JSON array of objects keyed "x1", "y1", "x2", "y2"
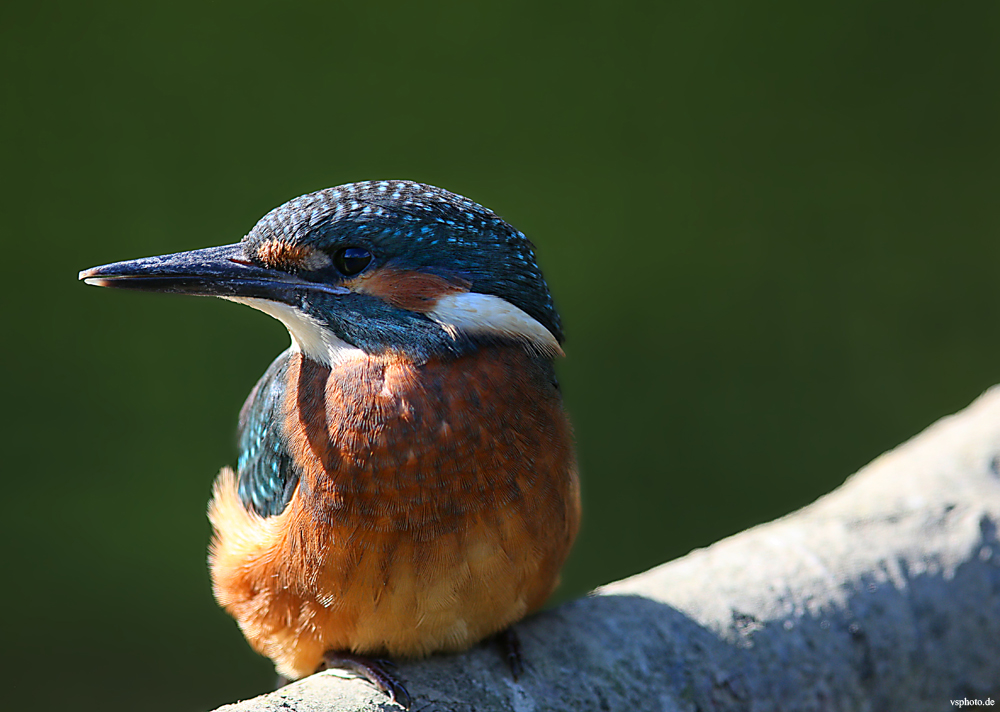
[{"x1": 80, "y1": 243, "x2": 348, "y2": 302}]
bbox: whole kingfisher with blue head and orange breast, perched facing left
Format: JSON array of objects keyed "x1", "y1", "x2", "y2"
[{"x1": 80, "y1": 180, "x2": 580, "y2": 706}]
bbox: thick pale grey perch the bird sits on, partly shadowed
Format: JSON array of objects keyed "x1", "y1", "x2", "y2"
[{"x1": 211, "y1": 387, "x2": 1000, "y2": 712}]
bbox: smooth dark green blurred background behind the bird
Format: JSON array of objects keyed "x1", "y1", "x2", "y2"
[{"x1": 0, "y1": 0, "x2": 1000, "y2": 710}]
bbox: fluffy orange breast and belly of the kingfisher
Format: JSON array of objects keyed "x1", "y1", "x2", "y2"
[{"x1": 209, "y1": 347, "x2": 580, "y2": 678}]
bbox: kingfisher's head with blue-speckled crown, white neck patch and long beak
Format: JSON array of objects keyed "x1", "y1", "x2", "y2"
[{"x1": 80, "y1": 181, "x2": 563, "y2": 363}]
